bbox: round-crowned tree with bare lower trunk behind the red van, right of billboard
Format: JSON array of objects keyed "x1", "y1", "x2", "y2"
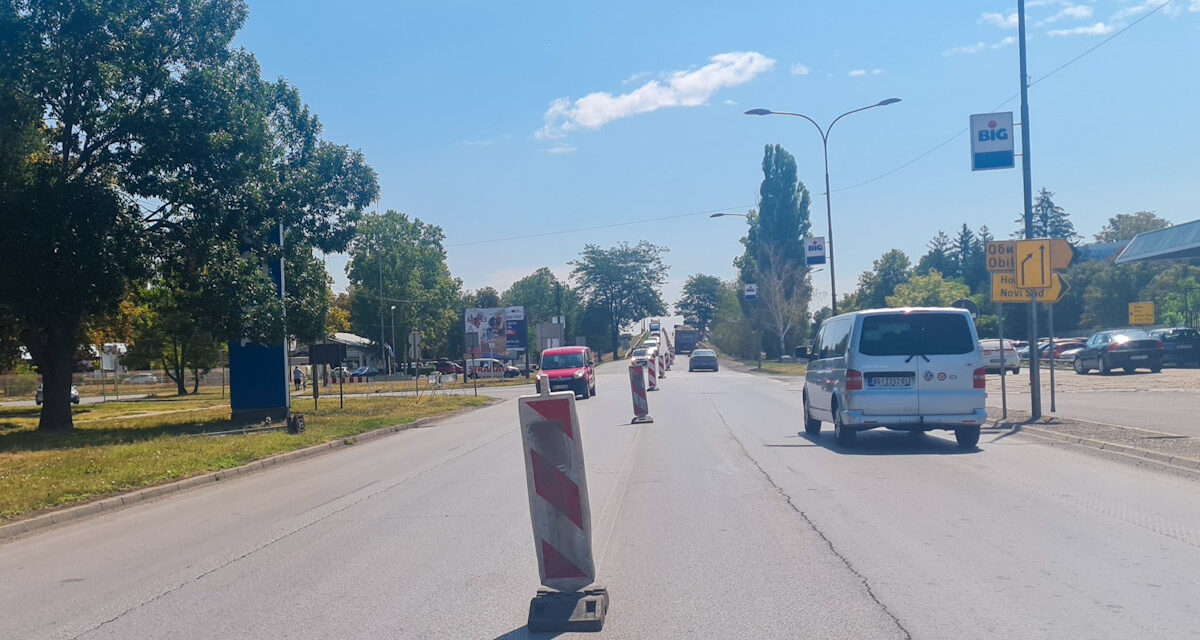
[{"x1": 571, "y1": 240, "x2": 667, "y2": 352}]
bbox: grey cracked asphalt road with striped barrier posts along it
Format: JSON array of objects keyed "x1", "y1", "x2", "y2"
[{"x1": 0, "y1": 358, "x2": 1200, "y2": 640}]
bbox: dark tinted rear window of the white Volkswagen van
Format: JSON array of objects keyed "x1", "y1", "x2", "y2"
[{"x1": 858, "y1": 313, "x2": 976, "y2": 355}]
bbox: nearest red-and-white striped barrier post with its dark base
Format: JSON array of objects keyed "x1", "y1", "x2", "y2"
[{"x1": 517, "y1": 373, "x2": 608, "y2": 632}]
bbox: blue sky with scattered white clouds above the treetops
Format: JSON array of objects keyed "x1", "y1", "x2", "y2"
[{"x1": 238, "y1": 0, "x2": 1200, "y2": 303}]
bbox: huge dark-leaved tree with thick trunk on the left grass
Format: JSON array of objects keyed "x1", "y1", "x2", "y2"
[{"x1": 0, "y1": 0, "x2": 378, "y2": 430}]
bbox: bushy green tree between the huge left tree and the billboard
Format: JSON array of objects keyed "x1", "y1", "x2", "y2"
[{"x1": 347, "y1": 209, "x2": 460, "y2": 365}]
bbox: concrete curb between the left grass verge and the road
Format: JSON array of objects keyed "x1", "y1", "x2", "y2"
[{"x1": 0, "y1": 399, "x2": 497, "y2": 542}]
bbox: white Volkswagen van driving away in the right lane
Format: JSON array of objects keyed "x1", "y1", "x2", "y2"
[{"x1": 804, "y1": 307, "x2": 988, "y2": 447}]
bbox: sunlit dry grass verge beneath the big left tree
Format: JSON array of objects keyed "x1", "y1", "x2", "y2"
[{"x1": 0, "y1": 394, "x2": 490, "y2": 522}]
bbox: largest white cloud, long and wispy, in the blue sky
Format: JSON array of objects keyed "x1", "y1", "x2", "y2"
[{"x1": 534, "y1": 52, "x2": 775, "y2": 138}]
